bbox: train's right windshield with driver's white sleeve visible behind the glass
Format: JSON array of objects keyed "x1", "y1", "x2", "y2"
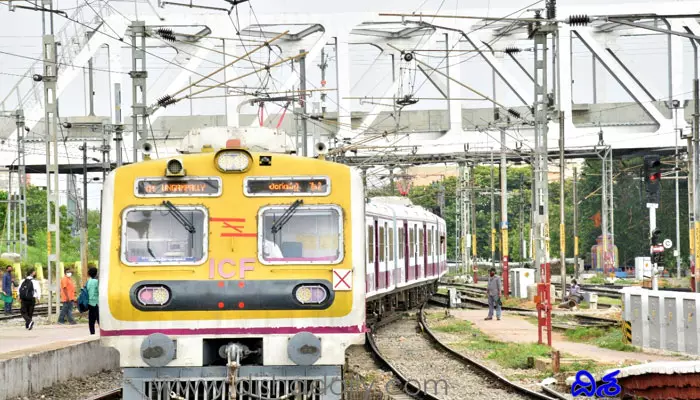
[{"x1": 258, "y1": 206, "x2": 343, "y2": 264}]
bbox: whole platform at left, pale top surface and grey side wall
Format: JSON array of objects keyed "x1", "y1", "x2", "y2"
[{"x1": 0, "y1": 324, "x2": 119, "y2": 400}]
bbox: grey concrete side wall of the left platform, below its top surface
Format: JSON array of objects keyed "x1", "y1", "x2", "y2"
[{"x1": 0, "y1": 340, "x2": 119, "y2": 400}]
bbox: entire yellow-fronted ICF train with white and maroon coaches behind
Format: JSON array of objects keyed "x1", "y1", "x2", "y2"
[{"x1": 100, "y1": 141, "x2": 446, "y2": 400}]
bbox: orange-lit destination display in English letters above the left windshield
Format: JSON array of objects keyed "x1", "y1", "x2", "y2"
[{"x1": 134, "y1": 177, "x2": 221, "y2": 197}]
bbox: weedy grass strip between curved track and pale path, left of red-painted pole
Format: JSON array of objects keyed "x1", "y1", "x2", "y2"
[{"x1": 431, "y1": 319, "x2": 551, "y2": 369}]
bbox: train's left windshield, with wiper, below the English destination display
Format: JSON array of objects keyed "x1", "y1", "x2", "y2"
[{"x1": 122, "y1": 206, "x2": 207, "y2": 265}]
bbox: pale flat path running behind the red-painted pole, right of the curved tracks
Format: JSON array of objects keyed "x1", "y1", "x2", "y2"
[{"x1": 450, "y1": 309, "x2": 681, "y2": 363}]
